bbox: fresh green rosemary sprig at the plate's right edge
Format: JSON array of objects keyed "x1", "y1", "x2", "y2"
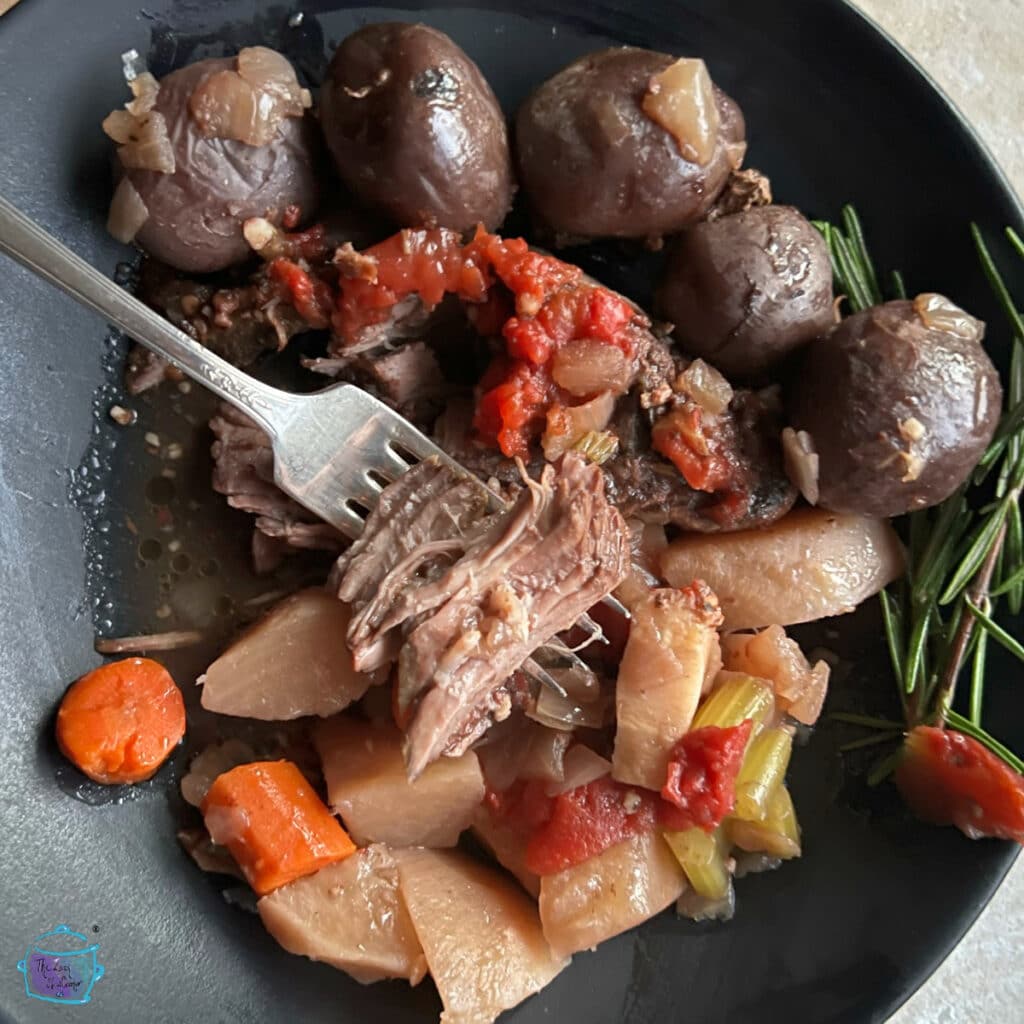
[{"x1": 814, "y1": 206, "x2": 1024, "y2": 784}]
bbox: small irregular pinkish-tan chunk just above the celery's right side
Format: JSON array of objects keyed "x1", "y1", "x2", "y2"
[{"x1": 722, "y1": 626, "x2": 828, "y2": 725}]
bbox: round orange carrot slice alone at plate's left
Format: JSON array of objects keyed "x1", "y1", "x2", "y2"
[{"x1": 56, "y1": 657, "x2": 185, "y2": 785}]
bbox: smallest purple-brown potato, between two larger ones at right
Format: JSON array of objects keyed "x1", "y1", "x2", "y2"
[{"x1": 658, "y1": 206, "x2": 834, "y2": 380}]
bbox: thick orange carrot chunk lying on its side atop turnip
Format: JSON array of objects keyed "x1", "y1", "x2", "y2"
[{"x1": 203, "y1": 761, "x2": 355, "y2": 896}]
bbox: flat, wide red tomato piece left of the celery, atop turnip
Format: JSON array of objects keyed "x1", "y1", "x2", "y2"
[{"x1": 526, "y1": 777, "x2": 657, "y2": 876}]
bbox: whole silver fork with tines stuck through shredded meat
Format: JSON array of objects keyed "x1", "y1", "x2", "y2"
[{"x1": 0, "y1": 197, "x2": 628, "y2": 696}]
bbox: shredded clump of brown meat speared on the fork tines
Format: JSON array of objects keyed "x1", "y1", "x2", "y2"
[{"x1": 338, "y1": 453, "x2": 630, "y2": 778}]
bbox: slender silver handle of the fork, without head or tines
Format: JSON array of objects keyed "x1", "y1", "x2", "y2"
[{"x1": 0, "y1": 196, "x2": 297, "y2": 438}]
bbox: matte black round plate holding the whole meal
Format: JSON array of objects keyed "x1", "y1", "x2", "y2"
[{"x1": 0, "y1": 0, "x2": 1024, "y2": 1024}]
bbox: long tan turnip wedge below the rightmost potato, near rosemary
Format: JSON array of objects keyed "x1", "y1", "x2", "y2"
[{"x1": 660, "y1": 509, "x2": 903, "y2": 630}]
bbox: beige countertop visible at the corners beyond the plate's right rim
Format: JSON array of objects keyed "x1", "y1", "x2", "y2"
[{"x1": 857, "y1": 0, "x2": 1024, "y2": 1024}]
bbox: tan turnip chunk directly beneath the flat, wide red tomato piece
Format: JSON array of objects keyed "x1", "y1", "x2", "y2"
[{"x1": 541, "y1": 833, "x2": 686, "y2": 956}]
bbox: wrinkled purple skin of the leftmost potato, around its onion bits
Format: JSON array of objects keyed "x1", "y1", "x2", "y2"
[{"x1": 125, "y1": 57, "x2": 318, "y2": 273}]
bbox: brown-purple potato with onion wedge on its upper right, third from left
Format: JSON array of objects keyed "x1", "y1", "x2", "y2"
[{"x1": 515, "y1": 46, "x2": 745, "y2": 241}]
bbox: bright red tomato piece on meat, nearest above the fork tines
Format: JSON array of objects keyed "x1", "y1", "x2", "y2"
[{"x1": 473, "y1": 359, "x2": 558, "y2": 459}]
